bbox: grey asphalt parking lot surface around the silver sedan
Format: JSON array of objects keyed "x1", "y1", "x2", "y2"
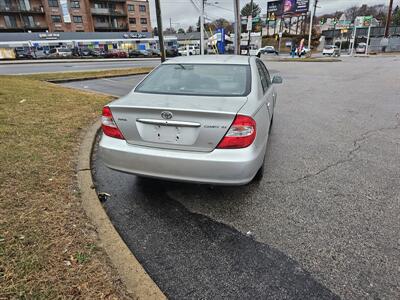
[{"x1": 81, "y1": 57, "x2": 400, "y2": 299}]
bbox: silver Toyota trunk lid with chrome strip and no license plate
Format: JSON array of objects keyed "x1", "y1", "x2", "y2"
[{"x1": 110, "y1": 93, "x2": 247, "y2": 152}]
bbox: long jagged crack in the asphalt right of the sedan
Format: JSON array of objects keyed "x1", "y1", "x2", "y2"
[{"x1": 266, "y1": 113, "x2": 400, "y2": 184}]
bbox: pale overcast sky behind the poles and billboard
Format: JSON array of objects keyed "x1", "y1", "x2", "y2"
[{"x1": 149, "y1": 0, "x2": 400, "y2": 29}]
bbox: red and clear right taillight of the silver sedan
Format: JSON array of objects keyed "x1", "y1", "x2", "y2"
[{"x1": 217, "y1": 115, "x2": 256, "y2": 149}]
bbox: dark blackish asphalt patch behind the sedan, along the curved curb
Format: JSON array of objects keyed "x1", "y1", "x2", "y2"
[{"x1": 92, "y1": 137, "x2": 339, "y2": 299}]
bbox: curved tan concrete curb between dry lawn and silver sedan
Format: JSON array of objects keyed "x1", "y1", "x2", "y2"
[{"x1": 77, "y1": 122, "x2": 167, "y2": 299}]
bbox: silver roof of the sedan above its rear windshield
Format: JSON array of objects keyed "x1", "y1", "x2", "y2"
[{"x1": 164, "y1": 55, "x2": 250, "y2": 65}]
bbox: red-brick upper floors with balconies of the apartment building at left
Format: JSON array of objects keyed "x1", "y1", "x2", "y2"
[{"x1": 0, "y1": 0, "x2": 152, "y2": 32}]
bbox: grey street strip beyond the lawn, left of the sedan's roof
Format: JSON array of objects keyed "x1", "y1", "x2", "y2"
[{"x1": 0, "y1": 60, "x2": 160, "y2": 75}]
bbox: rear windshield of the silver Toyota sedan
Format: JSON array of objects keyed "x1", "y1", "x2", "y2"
[{"x1": 135, "y1": 64, "x2": 250, "y2": 97}]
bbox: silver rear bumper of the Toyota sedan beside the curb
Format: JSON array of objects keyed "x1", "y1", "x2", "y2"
[{"x1": 99, "y1": 134, "x2": 265, "y2": 185}]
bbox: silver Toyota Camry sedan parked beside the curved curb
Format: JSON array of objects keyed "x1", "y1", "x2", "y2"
[{"x1": 100, "y1": 55, "x2": 282, "y2": 185}]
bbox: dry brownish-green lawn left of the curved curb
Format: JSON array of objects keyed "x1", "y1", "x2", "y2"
[{"x1": 0, "y1": 68, "x2": 150, "y2": 299}]
